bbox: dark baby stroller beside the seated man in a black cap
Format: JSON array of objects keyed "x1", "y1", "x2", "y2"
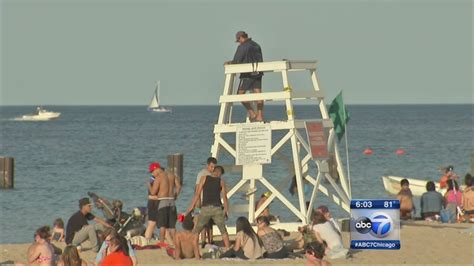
[{"x1": 87, "y1": 192, "x2": 146, "y2": 239}]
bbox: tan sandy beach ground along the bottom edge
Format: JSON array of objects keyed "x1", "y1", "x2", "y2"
[{"x1": 0, "y1": 221, "x2": 474, "y2": 265}]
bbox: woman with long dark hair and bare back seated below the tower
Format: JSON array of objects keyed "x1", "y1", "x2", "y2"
[{"x1": 220, "y1": 216, "x2": 263, "y2": 260}]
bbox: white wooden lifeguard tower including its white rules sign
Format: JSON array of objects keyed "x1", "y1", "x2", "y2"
[{"x1": 211, "y1": 60, "x2": 351, "y2": 232}]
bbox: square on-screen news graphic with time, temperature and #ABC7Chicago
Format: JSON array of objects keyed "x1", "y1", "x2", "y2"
[{"x1": 351, "y1": 199, "x2": 400, "y2": 250}]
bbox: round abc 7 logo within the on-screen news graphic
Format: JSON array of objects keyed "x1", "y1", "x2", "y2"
[{"x1": 354, "y1": 212, "x2": 393, "y2": 238}]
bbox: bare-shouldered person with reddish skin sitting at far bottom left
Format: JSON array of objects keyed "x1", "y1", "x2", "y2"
[{"x1": 27, "y1": 226, "x2": 55, "y2": 266}]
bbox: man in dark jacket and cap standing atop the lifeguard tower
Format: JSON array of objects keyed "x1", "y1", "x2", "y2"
[{"x1": 225, "y1": 31, "x2": 263, "y2": 122}]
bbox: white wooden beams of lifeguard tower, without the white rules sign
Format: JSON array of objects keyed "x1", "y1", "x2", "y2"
[{"x1": 211, "y1": 60, "x2": 351, "y2": 231}]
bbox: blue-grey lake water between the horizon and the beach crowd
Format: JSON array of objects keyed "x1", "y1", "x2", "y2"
[{"x1": 0, "y1": 105, "x2": 474, "y2": 243}]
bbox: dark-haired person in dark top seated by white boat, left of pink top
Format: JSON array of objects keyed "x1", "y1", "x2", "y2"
[{"x1": 420, "y1": 181, "x2": 444, "y2": 221}]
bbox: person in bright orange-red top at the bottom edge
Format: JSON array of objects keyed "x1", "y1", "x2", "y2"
[{"x1": 100, "y1": 235, "x2": 133, "y2": 266}]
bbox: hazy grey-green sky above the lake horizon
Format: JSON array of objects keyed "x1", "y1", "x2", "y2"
[{"x1": 0, "y1": 0, "x2": 474, "y2": 105}]
